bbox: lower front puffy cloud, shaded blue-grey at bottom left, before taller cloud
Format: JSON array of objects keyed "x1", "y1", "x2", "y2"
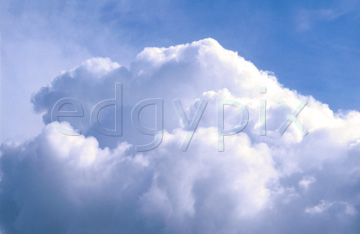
[{"x1": 0, "y1": 123, "x2": 277, "y2": 233}]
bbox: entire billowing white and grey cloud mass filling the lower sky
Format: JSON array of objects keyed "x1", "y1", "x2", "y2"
[{"x1": 0, "y1": 39, "x2": 360, "y2": 233}]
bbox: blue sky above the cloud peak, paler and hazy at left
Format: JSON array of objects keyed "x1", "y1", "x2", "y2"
[{"x1": 0, "y1": 0, "x2": 360, "y2": 139}]
